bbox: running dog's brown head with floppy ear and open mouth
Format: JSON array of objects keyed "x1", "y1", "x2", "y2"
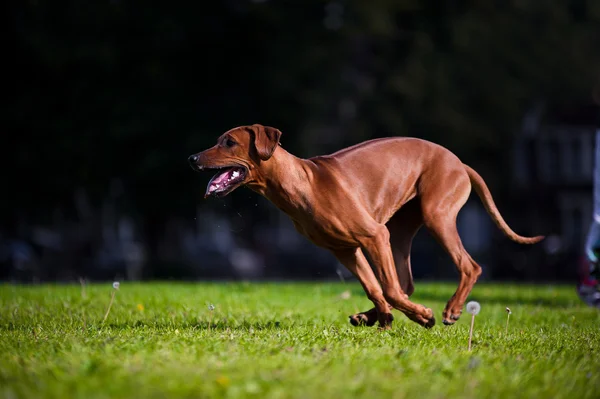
[{"x1": 188, "y1": 124, "x2": 281, "y2": 198}]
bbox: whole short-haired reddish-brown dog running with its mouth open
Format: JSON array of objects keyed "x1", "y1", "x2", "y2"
[{"x1": 189, "y1": 124, "x2": 544, "y2": 328}]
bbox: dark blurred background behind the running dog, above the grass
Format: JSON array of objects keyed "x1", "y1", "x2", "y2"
[{"x1": 0, "y1": 0, "x2": 600, "y2": 282}]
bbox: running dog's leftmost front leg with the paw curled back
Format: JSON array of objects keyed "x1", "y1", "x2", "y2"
[{"x1": 333, "y1": 248, "x2": 394, "y2": 329}]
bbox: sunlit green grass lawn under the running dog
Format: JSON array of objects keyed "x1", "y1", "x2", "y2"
[{"x1": 0, "y1": 282, "x2": 600, "y2": 399}]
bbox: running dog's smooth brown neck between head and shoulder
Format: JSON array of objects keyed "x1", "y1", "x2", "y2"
[{"x1": 251, "y1": 146, "x2": 314, "y2": 219}]
